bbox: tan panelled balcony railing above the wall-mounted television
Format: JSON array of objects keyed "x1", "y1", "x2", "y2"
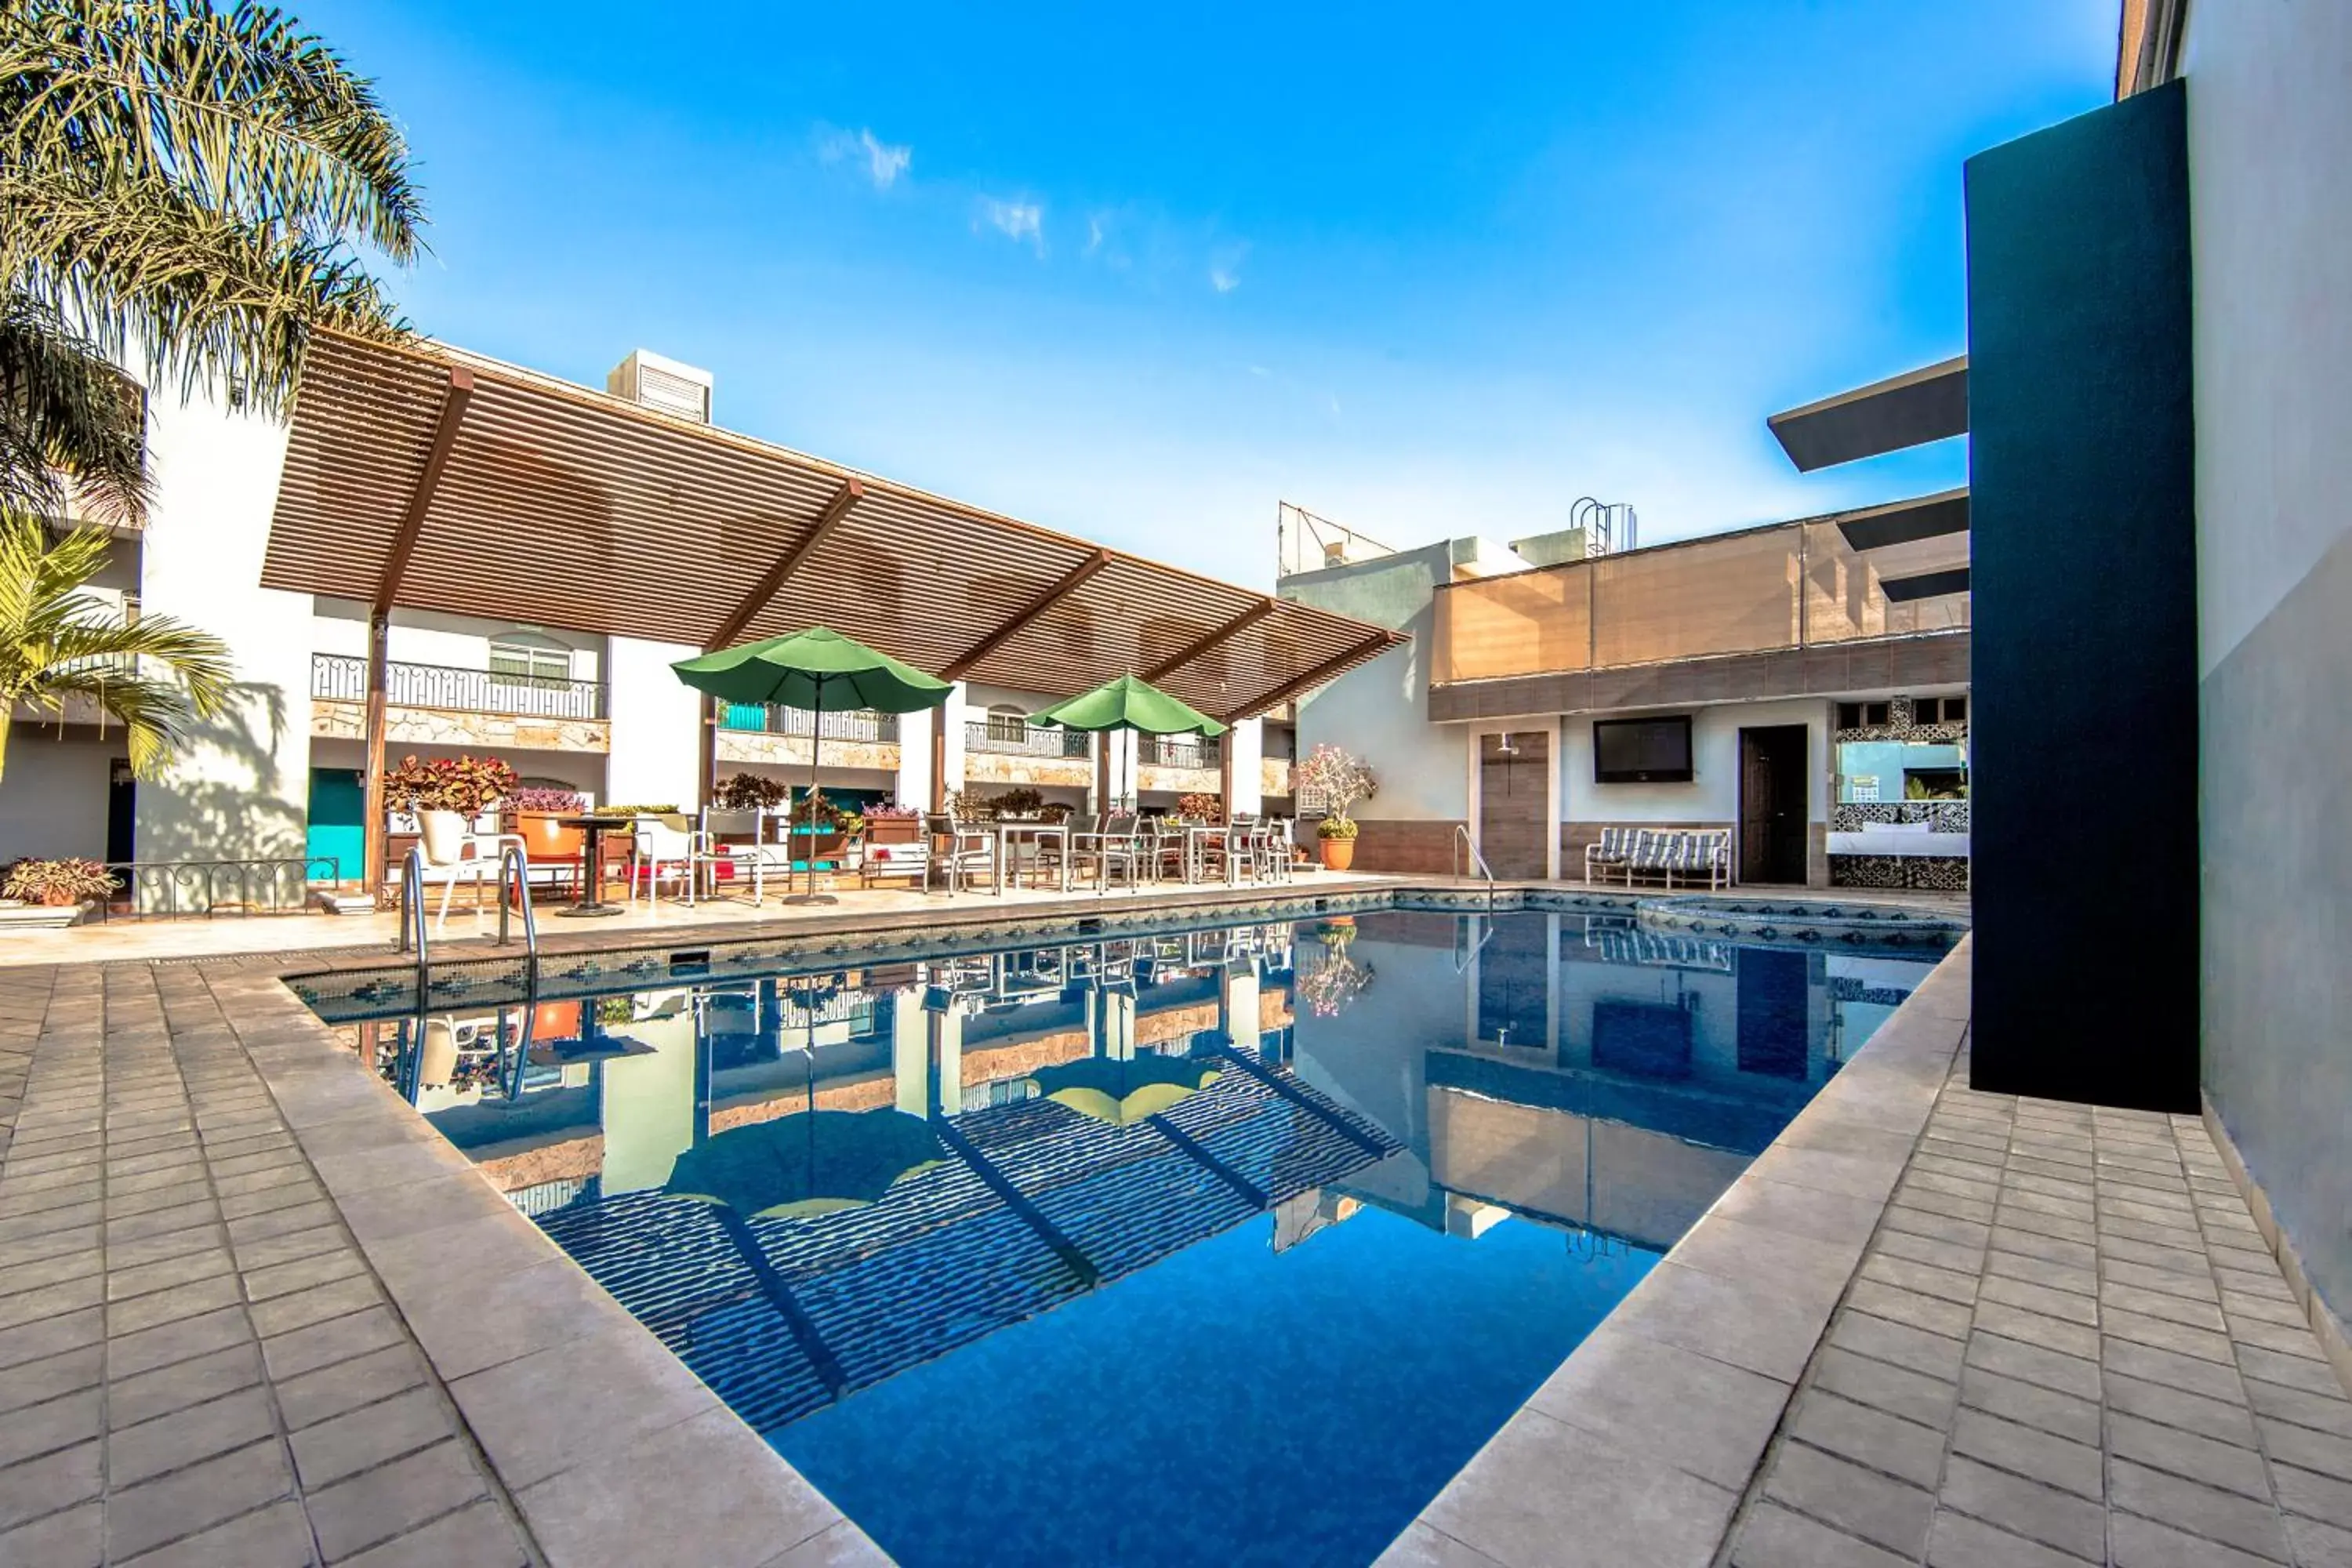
[{"x1": 1430, "y1": 522, "x2": 1969, "y2": 684}]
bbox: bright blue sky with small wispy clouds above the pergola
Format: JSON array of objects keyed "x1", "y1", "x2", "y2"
[{"x1": 299, "y1": 0, "x2": 2117, "y2": 586}]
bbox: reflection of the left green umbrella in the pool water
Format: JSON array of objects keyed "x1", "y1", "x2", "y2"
[{"x1": 663, "y1": 1109, "x2": 943, "y2": 1218}]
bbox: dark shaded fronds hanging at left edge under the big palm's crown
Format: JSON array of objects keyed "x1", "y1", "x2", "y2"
[{"x1": 0, "y1": 294, "x2": 148, "y2": 522}]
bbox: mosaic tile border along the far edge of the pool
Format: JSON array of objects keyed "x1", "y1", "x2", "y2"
[{"x1": 285, "y1": 886, "x2": 1969, "y2": 1022}]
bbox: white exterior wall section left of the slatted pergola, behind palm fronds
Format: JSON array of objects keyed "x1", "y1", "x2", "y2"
[{"x1": 136, "y1": 390, "x2": 310, "y2": 860}]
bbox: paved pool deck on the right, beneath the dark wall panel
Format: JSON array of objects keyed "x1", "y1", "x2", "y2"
[{"x1": 1383, "y1": 942, "x2": 2352, "y2": 1568}]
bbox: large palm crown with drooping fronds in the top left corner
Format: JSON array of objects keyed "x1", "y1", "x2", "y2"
[{"x1": 0, "y1": 0, "x2": 423, "y2": 517}]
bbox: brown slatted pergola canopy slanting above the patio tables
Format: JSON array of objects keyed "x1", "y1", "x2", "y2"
[{"x1": 261, "y1": 334, "x2": 1406, "y2": 879}]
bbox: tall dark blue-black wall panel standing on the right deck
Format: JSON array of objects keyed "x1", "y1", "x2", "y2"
[{"x1": 1966, "y1": 82, "x2": 2199, "y2": 1112}]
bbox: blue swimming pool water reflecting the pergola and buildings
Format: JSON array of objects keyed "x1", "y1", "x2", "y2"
[{"x1": 334, "y1": 909, "x2": 1933, "y2": 1568}]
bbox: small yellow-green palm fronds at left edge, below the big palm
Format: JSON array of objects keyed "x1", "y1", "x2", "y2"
[{"x1": 0, "y1": 513, "x2": 230, "y2": 779}]
